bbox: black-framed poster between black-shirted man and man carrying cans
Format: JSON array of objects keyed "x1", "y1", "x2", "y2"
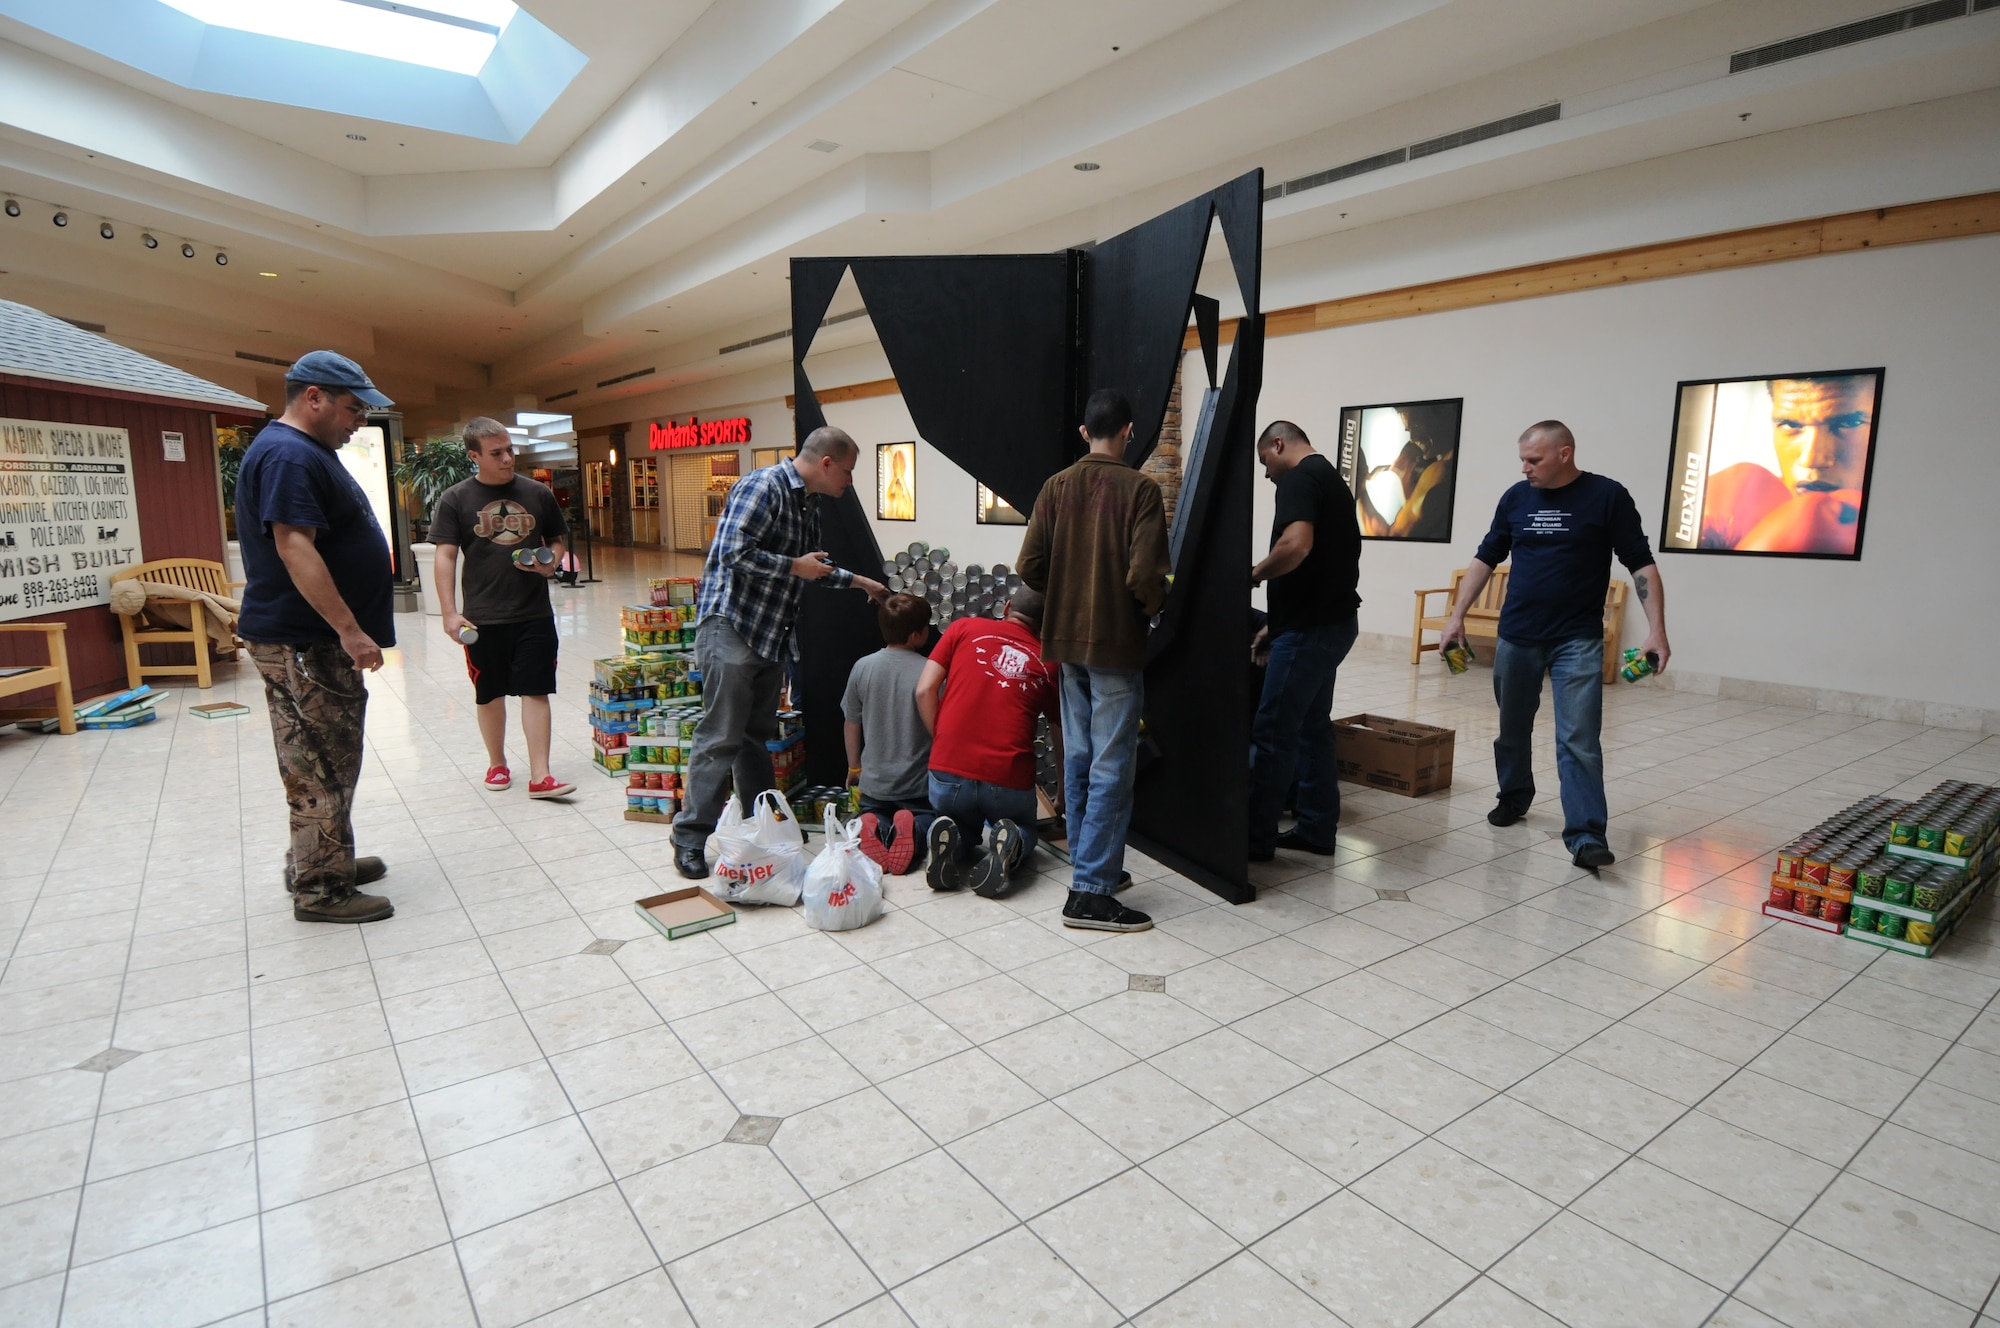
[{"x1": 1334, "y1": 396, "x2": 1466, "y2": 544}]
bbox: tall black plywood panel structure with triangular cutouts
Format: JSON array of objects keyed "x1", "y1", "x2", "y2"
[{"x1": 792, "y1": 172, "x2": 1264, "y2": 902}]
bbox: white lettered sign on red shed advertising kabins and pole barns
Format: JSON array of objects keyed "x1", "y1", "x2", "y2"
[{"x1": 0, "y1": 420, "x2": 146, "y2": 622}]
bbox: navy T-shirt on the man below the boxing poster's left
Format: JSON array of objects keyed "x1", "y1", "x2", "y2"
[{"x1": 1474, "y1": 470, "x2": 1652, "y2": 646}]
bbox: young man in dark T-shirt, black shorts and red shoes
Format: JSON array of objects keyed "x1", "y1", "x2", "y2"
[{"x1": 430, "y1": 416, "x2": 576, "y2": 798}]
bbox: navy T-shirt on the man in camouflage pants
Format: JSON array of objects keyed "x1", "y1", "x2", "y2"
[{"x1": 236, "y1": 420, "x2": 396, "y2": 646}]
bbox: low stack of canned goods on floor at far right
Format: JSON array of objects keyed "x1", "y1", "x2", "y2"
[{"x1": 1764, "y1": 780, "x2": 2000, "y2": 956}]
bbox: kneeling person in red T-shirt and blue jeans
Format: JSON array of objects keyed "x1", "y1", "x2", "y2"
[{"x1": 916, "y1": 586, "x2": 1060, "y2": 898}]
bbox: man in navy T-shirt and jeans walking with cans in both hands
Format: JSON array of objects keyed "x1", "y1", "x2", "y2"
[{"x1": 1440, "y1": 420, "x2": 1672, "y2": 870}]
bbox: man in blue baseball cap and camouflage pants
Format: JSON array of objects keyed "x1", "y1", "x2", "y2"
[{"x1": 236, "y1": 350, "x2": 396, "y2": 922}]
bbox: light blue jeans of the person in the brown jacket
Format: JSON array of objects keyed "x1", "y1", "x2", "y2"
[{"x1": 1062, "y1": 664, "x2": 1146, "y2": 894}]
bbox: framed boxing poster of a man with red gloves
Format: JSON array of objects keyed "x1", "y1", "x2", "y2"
[{"x1": 1660, "y1": 368, "x2": 1884, "y2": 560}]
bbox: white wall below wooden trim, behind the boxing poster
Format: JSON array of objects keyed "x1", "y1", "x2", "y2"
[{"x1": 1256, "y1": 236, "x2": 2000, "y2": 710}]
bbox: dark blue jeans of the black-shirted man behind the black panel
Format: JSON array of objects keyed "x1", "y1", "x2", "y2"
[{"x1": 1250, "y1": 618, "x2": 1362, "y2": 854}]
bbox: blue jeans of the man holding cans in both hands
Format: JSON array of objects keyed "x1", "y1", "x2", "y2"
[{"x1": 1494, "y1": 636, "x2": 1610, "y2": 854}]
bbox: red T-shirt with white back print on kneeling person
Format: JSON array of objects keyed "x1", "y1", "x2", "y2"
[{"x1": 930, "y1": 618, "x2": 1060, "y2": 788}]
